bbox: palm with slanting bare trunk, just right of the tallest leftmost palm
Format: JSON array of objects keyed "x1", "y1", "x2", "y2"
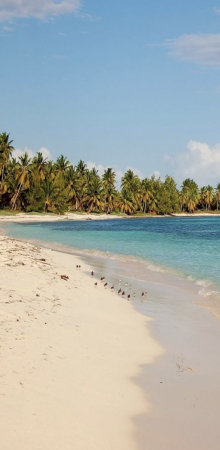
[{"x1": 11, "y1": 152, "x2": 31, "y2": 209}]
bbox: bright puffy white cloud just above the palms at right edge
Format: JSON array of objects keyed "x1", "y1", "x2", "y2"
[{"x1": 165, "y1": 141, "x2": 220, "y2": 186}]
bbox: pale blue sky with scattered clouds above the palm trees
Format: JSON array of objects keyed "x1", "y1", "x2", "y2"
[{"x1": 0, "y1": 0, "x2": 220, "y2": 186}]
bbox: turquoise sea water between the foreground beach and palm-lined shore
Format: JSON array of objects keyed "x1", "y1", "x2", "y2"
[{"x1": 4, "y1": 217, "x2": 220, "y2": 293}]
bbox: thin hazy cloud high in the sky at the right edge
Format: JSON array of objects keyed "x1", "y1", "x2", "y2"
[{"x1": 166, "y1": 34, "x2": 220, "y2": 66}]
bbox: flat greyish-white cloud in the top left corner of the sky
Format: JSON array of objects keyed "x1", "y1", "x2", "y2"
[{"x1": 0, "y1": 0, "x2": 82, "y2": 22}]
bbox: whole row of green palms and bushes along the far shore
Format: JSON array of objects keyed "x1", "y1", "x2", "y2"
[{"x1": 0, "y1": 132, "x2": 220, "y2": 215}]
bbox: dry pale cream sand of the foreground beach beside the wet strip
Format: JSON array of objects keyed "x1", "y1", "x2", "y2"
[{"x1": 0, "y1": 236, "x2": 163, "y2": 450}]
